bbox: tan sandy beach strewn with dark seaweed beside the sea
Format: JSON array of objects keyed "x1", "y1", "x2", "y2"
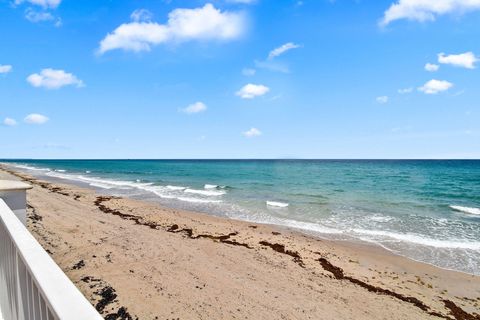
[{"x1": 0, "y1": 166, "x2": 480, "y2": 320}]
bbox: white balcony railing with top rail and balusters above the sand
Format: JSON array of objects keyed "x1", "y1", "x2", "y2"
[{"x1": 0, "y1": 198, "x2": 102, "y2": 320}]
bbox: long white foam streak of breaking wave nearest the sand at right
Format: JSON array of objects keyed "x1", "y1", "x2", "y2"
[{"x1": 347, "y1": 229, "x2": 480, "y2": 250}]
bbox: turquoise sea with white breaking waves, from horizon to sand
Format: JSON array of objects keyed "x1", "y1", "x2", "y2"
[{"x1": 3, "y1": 160, "x2": 480, "y2": 274}]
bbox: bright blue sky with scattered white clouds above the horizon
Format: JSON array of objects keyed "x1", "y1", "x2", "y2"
[{"x1": 0, "y1": 0, "x2": 480, "y2": 158}]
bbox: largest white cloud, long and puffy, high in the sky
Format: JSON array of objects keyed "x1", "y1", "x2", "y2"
[{"x1": 98, "y1": 3, "x2": 245, "y2": 54}]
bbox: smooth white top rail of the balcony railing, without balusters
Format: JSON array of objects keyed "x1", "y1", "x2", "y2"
[{"x1": 0, "y1": 199, "x2": 103, "y2": 320}]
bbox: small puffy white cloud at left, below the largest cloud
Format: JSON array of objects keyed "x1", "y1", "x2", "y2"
[{"x1": 27, "y1": 68, "x2": 84, "y2": 89}]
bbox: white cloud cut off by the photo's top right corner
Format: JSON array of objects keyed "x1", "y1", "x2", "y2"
[{"x1": 380, "y1": 0, "x2": 480, "y2": 26}]
